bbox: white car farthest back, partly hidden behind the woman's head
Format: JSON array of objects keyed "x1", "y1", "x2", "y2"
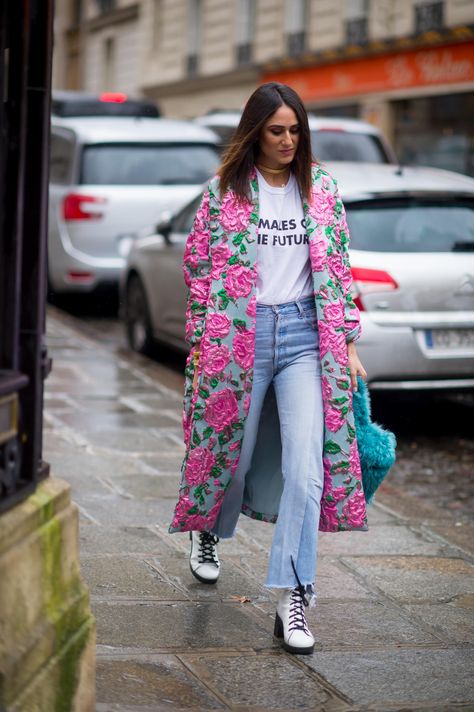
[{"x1": 194, "y1": 111, "x2": 397, "y2": 163}]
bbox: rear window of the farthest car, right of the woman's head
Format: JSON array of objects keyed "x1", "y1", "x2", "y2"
[{"x1": 311, "y1": 129, "x2": 389, "y2": 163}]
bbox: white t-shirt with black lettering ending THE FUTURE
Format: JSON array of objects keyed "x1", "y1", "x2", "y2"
[{"x1": 257, "y1": 170, "x2": 313, "y2": 304}]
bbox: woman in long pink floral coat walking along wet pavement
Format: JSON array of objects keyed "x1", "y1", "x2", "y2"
[{"x1": 170, "y1": 82, "x2": 367, "y2": 653}]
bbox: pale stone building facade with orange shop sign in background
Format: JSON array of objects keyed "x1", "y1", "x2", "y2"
[{"x1": 54, "y1": 0, "x2": 474, "y2": 174}]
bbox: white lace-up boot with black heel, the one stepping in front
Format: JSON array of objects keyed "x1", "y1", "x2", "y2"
[{"x1": 274, "y1": 587, "x2": 314, "y2": 655}]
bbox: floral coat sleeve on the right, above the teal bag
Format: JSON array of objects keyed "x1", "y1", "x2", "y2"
[{"x1": 334, "y1": 186, "x2": 361, "y2": 343}]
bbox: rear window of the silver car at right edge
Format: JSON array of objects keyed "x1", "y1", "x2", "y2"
[{"x1": 346, "y1": 199, "x2": 474, "y2": 252}]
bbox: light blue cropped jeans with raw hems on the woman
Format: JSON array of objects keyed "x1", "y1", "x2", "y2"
[{"x1": 213, "y1": 297, "x2": 324, "y2": 588}]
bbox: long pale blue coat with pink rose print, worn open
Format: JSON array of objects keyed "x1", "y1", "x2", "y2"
[{"x1": 170, "y1": 165, "x2": 367, "y2": 532}]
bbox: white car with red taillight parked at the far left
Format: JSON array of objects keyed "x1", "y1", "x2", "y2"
[{"x1": 48, "y1": 117, "x2": 219, "y2": 293}]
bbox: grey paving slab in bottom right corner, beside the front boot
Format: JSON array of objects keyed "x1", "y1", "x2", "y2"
[{"x1": 305, "y1": 648, "x2": 474, "y2": 712}]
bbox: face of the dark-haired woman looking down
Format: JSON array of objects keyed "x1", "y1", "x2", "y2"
[{"x1": 258, "y1": 104, "x2": 300, "y2": 168}]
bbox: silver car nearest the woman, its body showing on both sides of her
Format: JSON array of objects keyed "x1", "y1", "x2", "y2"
[{"x1": 122, "y1": 163, "x2": 474, "y2": 390}]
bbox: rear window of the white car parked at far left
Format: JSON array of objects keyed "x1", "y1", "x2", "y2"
[{"x1": 81, "y1": 143, "x2": 219, "y2": 185}]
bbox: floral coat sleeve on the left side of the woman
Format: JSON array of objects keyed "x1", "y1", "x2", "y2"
[{"x1": 183, "y1": 191, "x2": 211, "y2": 346}]
